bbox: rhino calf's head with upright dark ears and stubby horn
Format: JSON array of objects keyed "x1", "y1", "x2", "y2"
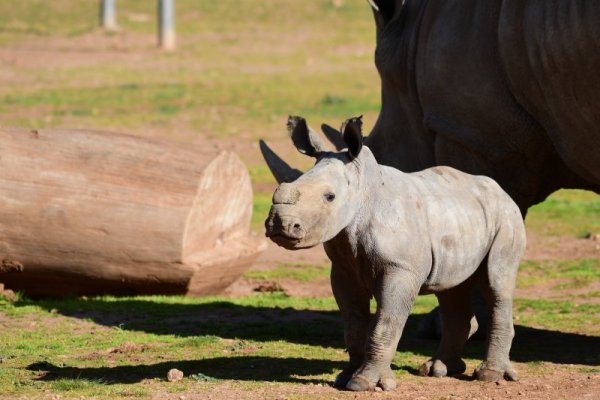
[{"x1": 260, "y1": 117, "x2": 376, "y2": 250}]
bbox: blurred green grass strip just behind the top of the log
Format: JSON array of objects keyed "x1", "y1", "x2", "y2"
[{"x1": 0, "y1": 71, "x2": 378, "y2": 135}]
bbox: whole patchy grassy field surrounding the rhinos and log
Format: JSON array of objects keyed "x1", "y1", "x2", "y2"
[{"x1": 0, "y1": 0, "x2": 600, "y2": 400}]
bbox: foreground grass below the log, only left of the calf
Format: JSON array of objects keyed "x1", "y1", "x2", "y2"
[{"x1": 0, "y1": 294, "x2": 344, "y2": 398}]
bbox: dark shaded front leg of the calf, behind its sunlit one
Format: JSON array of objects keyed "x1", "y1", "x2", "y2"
[{"x1": 331, "y1": 261, "x2": 371, "y2": 387}]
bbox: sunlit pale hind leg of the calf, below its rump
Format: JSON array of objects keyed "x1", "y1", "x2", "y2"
[{"x1": 474, "y1": 228, "x2": 525, "y2": 381}]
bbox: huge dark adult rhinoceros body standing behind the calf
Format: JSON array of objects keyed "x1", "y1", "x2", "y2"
[{"x1": 366, "y1": 0, "x2": 600, "y2": 214}]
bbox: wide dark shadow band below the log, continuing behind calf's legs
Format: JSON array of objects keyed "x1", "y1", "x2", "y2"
[{"x1": 16, "y1": 298, "x2": 600, "y2": 371}]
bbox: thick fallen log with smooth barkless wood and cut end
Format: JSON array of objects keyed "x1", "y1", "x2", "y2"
[{"x1": 0, "y1": 129, "x2": 265, "y2": 296}]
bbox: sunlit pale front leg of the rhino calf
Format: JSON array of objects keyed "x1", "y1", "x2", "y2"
[{"x1": 346, "y1": 269, "x2": 422, "y2": 391}]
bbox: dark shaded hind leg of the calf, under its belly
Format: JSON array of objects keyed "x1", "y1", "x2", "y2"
[{"x1": 419, "y1": 282, "x2": 476, "y2": 377}]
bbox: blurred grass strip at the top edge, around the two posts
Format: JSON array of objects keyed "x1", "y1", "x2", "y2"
[{"x1": 0, "y1": 0, "x2": 371, "y2": 41}]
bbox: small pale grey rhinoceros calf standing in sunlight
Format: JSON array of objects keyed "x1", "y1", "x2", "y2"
[{"x1": 261, "y1": 117, "x2": 525, "y2": 391}]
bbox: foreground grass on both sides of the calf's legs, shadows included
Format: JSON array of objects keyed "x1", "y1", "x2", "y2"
[{"x1": 0, "y1": 293, "x2": 600, "y2": 398}]
